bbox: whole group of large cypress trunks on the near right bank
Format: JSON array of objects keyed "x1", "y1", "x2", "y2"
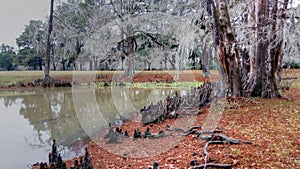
[{"x1": 207, "y1": 0, "x2": 288, "y2": 98}]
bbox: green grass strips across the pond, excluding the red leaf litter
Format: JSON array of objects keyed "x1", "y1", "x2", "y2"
[{"x1": 0, "y1": 69, "x2": 300, "y2": 88}]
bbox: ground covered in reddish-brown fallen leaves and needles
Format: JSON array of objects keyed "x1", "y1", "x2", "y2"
[{"x1": 6, "y1": 69, "x2": 300, "y2": 169}]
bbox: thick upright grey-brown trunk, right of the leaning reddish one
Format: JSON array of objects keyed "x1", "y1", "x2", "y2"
[{"x1": 247, "y1": 0, "x2": 281, "y2": 98}]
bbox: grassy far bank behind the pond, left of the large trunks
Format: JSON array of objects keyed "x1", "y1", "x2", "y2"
[{"x1": 0, "y1": 70, "x2": 216, "y2": 87}]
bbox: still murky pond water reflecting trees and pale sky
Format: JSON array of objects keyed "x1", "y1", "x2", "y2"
[{"x1": 0, "y1": 88, "x2": 182, "y2": 169}]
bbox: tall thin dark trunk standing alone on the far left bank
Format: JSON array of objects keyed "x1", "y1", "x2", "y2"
[{"x1": 44, "y1": 0, "x2": 54, "y2": 84}]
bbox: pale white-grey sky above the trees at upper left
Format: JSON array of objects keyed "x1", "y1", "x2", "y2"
[{"x1": 0, "y1": 0, "x2": 300, "y2": 46}]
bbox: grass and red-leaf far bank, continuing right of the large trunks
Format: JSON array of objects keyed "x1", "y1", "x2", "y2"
[{"x1": 0, "y1": 69, "x2": 300, "y2": 87}]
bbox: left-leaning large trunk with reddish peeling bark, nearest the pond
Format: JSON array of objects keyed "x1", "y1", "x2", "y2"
[{"x1": 207, "y1": 0, "x2": 242, "y2": 97}]
